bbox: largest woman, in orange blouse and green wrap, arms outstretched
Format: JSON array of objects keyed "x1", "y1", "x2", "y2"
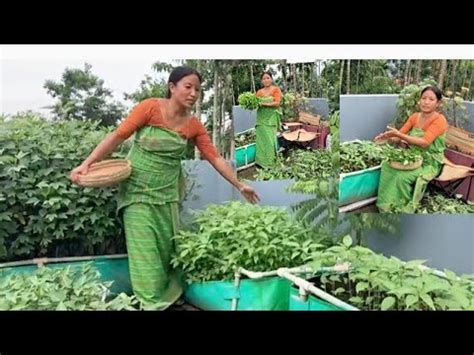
[{"x1": 71, "y1": 67, "x2": 259, "y2": 309}]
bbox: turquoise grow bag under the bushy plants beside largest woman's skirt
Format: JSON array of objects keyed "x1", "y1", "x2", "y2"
[{"x1": 185, "y1": 277, "x2": 291, "y2": 311}]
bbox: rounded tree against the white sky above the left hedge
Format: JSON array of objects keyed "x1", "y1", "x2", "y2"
[{"x1": 43, "y1": 63, "x2": 125, "y2": 125}]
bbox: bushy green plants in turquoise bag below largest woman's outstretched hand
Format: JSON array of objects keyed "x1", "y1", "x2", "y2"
[{"x1": 172, "y1": 201, "x2": 320, "y2": 282}]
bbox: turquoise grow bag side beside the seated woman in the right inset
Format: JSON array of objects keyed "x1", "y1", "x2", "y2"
[{"x1": 339, "y1": 165, "x2": 381, "y2": 206}]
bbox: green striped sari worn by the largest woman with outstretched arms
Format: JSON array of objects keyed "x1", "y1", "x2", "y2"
[{"x1": 118, "y1": 126, "x2": 188, "y2": 309}]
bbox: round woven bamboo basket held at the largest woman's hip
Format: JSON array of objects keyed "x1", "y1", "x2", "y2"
[{"x1": 79, "y1": 159, "x2": 132, "y2": 187}]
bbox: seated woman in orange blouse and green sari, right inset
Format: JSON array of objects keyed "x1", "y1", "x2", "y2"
[{"x1": 375, "y1": 86, "x2": 448, "y2": 213}]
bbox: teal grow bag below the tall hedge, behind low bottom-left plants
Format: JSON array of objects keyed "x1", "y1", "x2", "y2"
[{"x1": 0, "y1": 255, "x2": 132, "y2": 295}]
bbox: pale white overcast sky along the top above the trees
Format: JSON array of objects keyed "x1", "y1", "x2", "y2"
[{"x1": 0, "y1": 45, "x2": 474, "y2": 114}]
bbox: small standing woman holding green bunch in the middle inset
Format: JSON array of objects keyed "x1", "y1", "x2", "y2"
[{"x1": 255, "y1": 72, "x2": 282, "y2": 168}]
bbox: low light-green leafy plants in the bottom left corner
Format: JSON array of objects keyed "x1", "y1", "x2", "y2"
[{"x1": 0, "y1": 264, "x2": 138, "y2": 311}]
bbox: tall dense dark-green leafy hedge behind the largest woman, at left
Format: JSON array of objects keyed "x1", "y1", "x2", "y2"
[{"x1": 0, "y1": 117, "x2": 129, "y2": 261}]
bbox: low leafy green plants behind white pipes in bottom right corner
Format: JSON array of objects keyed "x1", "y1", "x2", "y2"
[{"x1": 312, "y1": 237, "x2": 474, "y2": 310}]
